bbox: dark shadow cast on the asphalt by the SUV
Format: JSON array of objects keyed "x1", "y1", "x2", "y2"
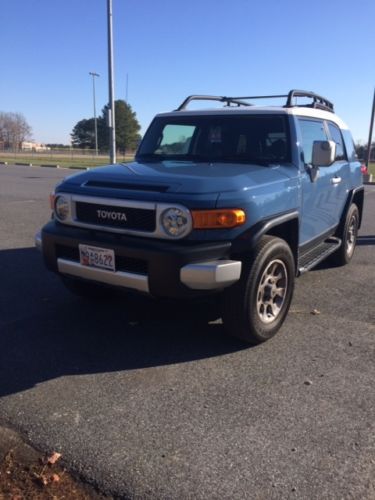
[{"x1": 0, "y1": 248, "x2": 248, "y2": 396}]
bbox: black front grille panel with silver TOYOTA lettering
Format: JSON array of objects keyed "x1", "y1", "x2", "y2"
[{"x1": 76, "y1": 202, "x2": 155, "y2": 232}]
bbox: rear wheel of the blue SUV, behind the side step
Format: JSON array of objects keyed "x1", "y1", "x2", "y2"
[{"x1": 331, "y1": 203, "x2": 359, "y2": 266}]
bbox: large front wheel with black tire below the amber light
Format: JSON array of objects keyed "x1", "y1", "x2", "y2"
[{"x1": 222, "y1": 236, "x2": 295, "y2": 344}]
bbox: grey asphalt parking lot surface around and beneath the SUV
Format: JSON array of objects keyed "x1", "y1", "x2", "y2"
[{"x1": 0, "y1": 165, "x2": 375, "y2": 499}]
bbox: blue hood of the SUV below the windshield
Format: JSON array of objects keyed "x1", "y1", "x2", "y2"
[{"x1": 61, "y1": 161, "x2": 294, "y2": 195}]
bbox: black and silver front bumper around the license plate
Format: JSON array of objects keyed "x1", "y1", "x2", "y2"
[{"x1": 35, "y1": 221, "x2": 242, "y2": 297}]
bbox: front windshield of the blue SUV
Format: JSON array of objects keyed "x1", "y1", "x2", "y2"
[{"x1": 136, "y1": 114, "x2": 290, "y2": 164}]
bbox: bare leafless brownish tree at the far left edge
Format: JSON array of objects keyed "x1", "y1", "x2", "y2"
[{"x1": 0, "y1": 111, "x2": 31, "y2": 151}]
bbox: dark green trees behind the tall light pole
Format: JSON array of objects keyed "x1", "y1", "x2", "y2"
[{"x1": 71, "y1": 99, "x2": 141, "y2": 153}]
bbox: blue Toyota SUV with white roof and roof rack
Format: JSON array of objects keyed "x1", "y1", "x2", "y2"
[{"x1": 36, "y1": 90, "x2": 364, "y2": 343}]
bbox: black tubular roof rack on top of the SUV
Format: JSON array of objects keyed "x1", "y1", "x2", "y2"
[{"x1": 176, "y1": 89, "x2": 334, "y2": 113}]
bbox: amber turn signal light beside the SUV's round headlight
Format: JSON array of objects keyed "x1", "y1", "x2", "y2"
[{"x1": 191, "y1": 208, "x2": 246, "y2": 229}]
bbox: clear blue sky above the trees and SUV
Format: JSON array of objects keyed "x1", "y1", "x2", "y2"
[{"x1": 0, "y1": 0, "x2": 375, "y2": 144}]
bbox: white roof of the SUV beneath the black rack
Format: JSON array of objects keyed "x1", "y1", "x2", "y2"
[{"x1": 157, "y1": 106, "x2": 349, "y2": 130}]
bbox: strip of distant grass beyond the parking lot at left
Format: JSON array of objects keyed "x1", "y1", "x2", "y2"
[{"x1": 0, "y1": 154, "x2": 133, "y2": 169}]
